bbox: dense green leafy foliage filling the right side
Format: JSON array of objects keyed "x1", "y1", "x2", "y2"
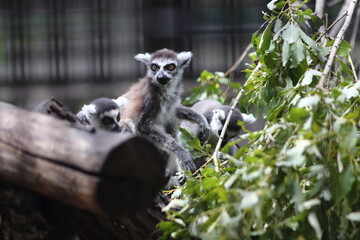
[{"x1": 159, "y1": 0, "x2": 360, "y2": 239}]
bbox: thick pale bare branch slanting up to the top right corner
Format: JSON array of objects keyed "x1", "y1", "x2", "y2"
[{"x1": 318, "y1": 0, "x2": 357, "y2": 88}]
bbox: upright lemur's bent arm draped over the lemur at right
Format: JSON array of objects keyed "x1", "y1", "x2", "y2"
[{"x1": 176, "y1": 106, "x2": 210, "y2": 142}]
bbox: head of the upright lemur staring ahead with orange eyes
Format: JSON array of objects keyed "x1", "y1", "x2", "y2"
[{"x1": 135, "y1": 48, "x2": 192, "y2": 85}]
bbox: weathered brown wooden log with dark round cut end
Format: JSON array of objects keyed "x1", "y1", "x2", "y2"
[{"x1": 0, "y1": 102, "x2": 166, "y2": 215}]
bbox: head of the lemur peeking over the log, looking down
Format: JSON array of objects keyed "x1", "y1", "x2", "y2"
[{"x1": 76, "y1": 97, "x2": 121, "y2": 132}]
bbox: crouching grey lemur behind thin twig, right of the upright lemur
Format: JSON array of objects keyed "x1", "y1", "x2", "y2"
[{"x1": 181, "y1": 99, "x2": 256, "y2": 146}]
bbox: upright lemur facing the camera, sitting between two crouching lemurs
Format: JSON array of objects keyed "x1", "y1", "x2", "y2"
[{"x1": 118, "y1": 49, "x2": 209, "y2": 181}]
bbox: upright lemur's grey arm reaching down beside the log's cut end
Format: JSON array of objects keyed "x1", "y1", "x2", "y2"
[{"x1": 138, "y1": 121, "x2": 196, "y2": 172}]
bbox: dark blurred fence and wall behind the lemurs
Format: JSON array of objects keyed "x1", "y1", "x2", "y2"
[{"x1": 0, "y1": 0, "x2": 360, "y2": 112}]
